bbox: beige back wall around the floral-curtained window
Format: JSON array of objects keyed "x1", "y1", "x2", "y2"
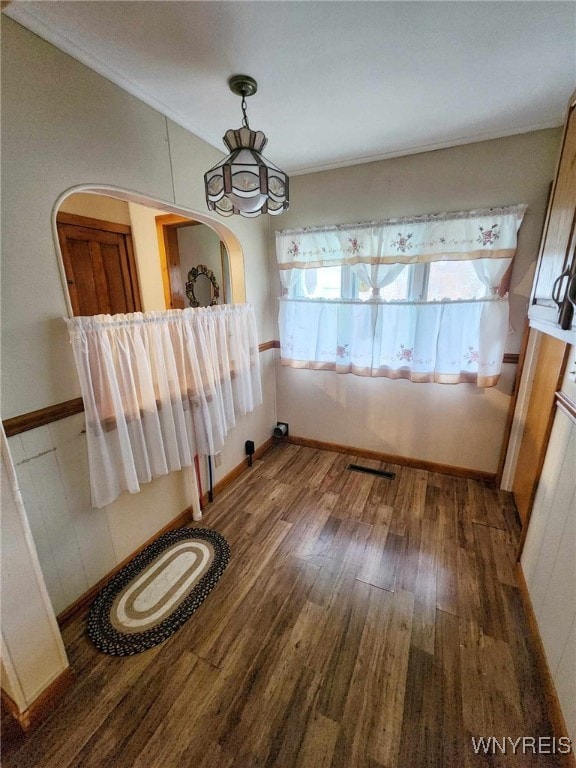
[{"x1": 272, "y1": 129, "x2": 561, "y2": 472}]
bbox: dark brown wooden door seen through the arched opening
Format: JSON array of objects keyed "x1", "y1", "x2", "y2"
[{"x1": 57, "y1": 214, "x2": 142, "y2": 315}]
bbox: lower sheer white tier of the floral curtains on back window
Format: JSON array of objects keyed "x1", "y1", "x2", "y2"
[{"x1": 279, "y1": 297, "x2": 508, "y2": 387}]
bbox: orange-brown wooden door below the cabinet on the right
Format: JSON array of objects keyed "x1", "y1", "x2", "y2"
[{"x1": 512, "y1": 330, "x2": 568, "y2": 529}]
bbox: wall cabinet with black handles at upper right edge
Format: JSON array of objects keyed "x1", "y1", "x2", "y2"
[{"x1": 528, "y1": 93, "x2": 576, "y2": 344}]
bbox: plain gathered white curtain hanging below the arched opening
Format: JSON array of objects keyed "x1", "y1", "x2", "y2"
[{"x1": 67, "y1": 305, "x2": 262, "y2": 507}]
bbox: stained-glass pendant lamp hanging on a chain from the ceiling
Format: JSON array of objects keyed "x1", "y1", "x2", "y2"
[{"x1": 204, "y1": 75, "x2": 289, "y2": 217}]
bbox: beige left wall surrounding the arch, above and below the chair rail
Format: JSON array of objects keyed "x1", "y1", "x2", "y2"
[{"x1": 1, "y1": 18, "x2": 275, "y2": 704}]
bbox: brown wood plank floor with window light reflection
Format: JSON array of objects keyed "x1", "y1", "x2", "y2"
[{"x1": 2, "y1": 445, "x2": 563, "y2": 768}]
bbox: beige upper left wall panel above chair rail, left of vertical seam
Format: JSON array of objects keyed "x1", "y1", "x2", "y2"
[{"x1": 2, "y1": 18, "x2": 172, "y2": 418}]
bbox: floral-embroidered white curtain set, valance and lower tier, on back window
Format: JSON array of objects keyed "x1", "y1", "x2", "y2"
[{"x1": 276, "y1": 205, "x2": 526, "y2": 386}]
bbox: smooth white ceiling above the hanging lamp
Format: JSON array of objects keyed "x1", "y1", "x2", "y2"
[{"x1": 4, "y1": 0, "x2": 576, "y2": 173}]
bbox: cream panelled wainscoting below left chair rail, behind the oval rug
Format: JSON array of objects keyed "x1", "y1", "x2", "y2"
[{"x1": 8, "y1": 413, "x2": 188, "y2": 614}]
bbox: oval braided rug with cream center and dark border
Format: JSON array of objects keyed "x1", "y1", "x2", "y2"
[{"x1": 88, "y1": 528, "x2": 230, "y2": 656}]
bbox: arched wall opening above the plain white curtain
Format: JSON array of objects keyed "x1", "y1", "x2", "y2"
[{"x1": 53, "y1": 185, "x2": 246, "y2": 316}]
